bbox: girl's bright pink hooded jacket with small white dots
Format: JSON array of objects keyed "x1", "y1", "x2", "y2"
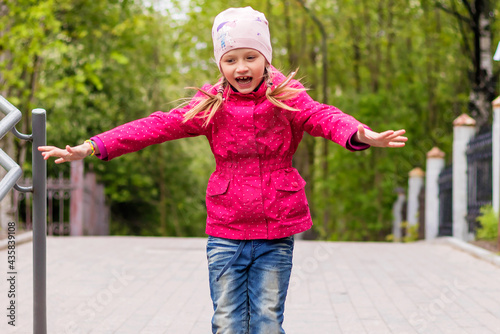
[{"x1": 92, "y1": 68, "x2": 369, "y2": 239}]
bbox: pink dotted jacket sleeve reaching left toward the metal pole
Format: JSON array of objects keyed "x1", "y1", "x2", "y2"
[{"x1": 91, "y1": 87, "x2": 210, "y2": 161}]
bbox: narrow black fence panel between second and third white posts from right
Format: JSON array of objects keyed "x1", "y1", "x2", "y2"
[{"x1": 438, "y1": 166, "x2": 453, "y2": 237}]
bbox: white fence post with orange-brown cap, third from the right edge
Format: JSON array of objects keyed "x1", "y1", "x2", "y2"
[{"x1": 425, "y1": 147, "x2": 445, "y2": 240}]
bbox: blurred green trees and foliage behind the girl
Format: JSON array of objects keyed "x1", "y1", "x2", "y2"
[{"x1": 0, "y1": 0, "x2": 500, "y2": 241}]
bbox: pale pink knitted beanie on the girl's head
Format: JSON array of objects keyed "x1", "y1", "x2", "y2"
[{"x1": 212, "y1": 7, "x2": 273, "y2": 70}]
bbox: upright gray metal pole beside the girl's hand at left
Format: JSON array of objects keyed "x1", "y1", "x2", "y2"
[{"x1": 32, "y1": 109, "x2": 47, "y2": 334}]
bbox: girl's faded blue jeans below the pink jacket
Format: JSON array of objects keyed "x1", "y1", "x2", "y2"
[{"x1": 207, "y1": 236, "x2": 294, "y2": 334}]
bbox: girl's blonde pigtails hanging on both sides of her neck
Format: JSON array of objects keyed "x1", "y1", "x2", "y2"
[{"x1": 183, "y1": 66, "x2": 306, "y2": 127}]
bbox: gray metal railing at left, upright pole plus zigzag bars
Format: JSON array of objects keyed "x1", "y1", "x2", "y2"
[{"x1": 0, "y1": 95, "x2": 47, "y2": 334}]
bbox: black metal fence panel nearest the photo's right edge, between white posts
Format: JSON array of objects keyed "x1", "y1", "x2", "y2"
[{"x1": 467, "y1": 132, "x2": 493, "y2": 233}]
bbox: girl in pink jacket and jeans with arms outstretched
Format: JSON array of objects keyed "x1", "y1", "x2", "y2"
[{"x1": 40, "y1": 7, "x2": 407, "y2": 334}]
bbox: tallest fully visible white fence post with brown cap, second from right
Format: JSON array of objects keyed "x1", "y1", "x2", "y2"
[{"x1": 453, "y1": 114, "x2": 476, "y2": 241}]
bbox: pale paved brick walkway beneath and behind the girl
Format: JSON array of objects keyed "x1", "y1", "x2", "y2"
[{"x1": 0, "y1": 237, "x2": 500, "y2": 334}]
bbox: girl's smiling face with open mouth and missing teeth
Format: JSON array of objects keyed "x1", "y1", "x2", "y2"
[{"x1": 220, "y1": 49, "x2": 266, "y2": 94}]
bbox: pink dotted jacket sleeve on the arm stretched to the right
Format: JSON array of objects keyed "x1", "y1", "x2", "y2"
[{"x1": 287, "y1": 81, "x2": 370, "y2": 151}]
